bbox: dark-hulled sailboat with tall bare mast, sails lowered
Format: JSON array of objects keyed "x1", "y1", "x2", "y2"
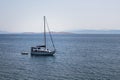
[{"x1": 31, "y1": 16, "x2": 56, "y2": 56}]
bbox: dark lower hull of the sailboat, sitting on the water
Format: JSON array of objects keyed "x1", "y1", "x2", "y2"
[{"x1": 31, "y1": 51, "x2": 55, "y2": 56}]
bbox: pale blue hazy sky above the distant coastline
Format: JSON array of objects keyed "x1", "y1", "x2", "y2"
[{"x1": 0, "y1": 0, "x2": 120, "y2": 32}]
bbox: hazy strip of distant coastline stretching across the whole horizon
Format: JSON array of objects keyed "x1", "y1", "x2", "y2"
[{"x1": 0, "y1": 30, "x2": 120, "y2": 34}]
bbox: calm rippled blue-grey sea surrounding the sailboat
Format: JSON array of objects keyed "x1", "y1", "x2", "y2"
[{"x1": 0, "y1": 34, "x2": 120, "y2": 80}]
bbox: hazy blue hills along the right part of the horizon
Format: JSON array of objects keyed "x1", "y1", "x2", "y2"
[{"x1": 73, "y1": 30, "x2": 120, "y2": 34}]
